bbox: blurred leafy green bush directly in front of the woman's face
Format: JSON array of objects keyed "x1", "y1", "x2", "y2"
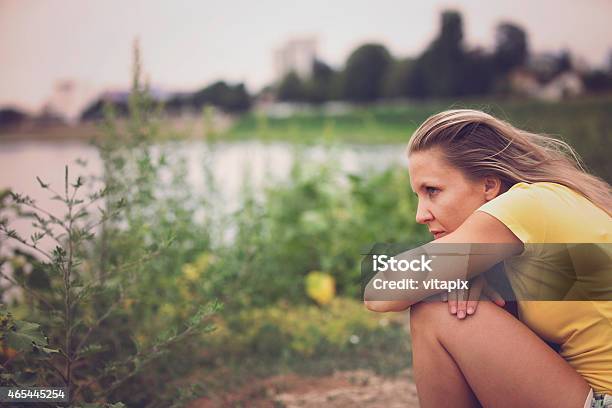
[{"x1": 202, "y1": 151, "x2": 427, "y2": 313}]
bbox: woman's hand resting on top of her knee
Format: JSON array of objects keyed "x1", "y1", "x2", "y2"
[{"x1": 440, "y1": 275, "x2": 506, "y2": 319}]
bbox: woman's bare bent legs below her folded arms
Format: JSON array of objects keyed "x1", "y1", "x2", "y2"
[{"x1": 410, "y1": 302, "x2": 589, "y2": 408}]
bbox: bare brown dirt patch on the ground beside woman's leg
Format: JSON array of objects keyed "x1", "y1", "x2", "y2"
[{"x1": 189, "y1": 370, "x2": 419, "y2": 408}]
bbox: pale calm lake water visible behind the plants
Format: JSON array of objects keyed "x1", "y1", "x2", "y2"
[{"x1": 0, "y1": 141, "x2": 406, "y2": 253}]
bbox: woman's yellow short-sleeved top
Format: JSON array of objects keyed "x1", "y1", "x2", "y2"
[{"x1": 479, "y1": 182, "x2": 612, "y2": 393}]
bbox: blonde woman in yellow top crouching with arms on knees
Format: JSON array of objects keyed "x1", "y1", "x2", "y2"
[{"x1": 365, "y1": 110, "x2": 612, "y2": 407}]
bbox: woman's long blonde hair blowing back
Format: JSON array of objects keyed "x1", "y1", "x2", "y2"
[{"x1": 407, "y1": 109, "x2": 612, "y2": 215}]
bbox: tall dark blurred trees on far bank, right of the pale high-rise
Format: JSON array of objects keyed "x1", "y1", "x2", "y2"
[{"x1": 276, "y1": 10, "x2": 596, "y2": 103}]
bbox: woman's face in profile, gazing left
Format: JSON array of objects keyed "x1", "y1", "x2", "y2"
[{"x1": 408, "y1": 148, "x2": 491, "y2": 239}]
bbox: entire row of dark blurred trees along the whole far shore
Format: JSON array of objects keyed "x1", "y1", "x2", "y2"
[{"x1": 0, "y1": 10, "x2": 612, "y2": 126}]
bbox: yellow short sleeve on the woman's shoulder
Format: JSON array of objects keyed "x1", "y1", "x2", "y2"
[{"x1": 477, "y1": 183, "x2": 549, "y2": 244}]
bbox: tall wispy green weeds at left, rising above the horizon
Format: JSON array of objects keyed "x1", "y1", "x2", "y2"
[{"x1": 0, "y1": 43, "x2": 219, "y2": 407}]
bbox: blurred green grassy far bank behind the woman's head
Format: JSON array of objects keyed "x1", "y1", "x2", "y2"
[{"x1": 224, "y1": 95, "x2": 612, "y2": 181}]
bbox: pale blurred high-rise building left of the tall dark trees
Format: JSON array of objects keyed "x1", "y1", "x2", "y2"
[{"x1": 274, "y1": 37, "x2": 317, "y2": 80}]
